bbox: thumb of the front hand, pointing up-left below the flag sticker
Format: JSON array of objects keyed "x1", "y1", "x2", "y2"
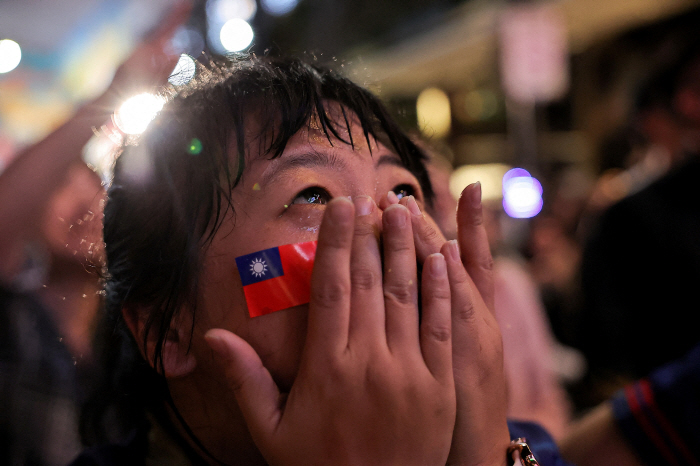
[{"x1": 204, "y1": 329, "x2": 282, "y2": 444}]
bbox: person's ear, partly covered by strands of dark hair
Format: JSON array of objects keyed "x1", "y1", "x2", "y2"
[{"x1": 122, "y1": 306, "x2": 197, "y2": 379}]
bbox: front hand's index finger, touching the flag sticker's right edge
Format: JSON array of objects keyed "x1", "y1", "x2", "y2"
[{"x1": 305, "y1": 197, "x2": 355, "y2": 355}]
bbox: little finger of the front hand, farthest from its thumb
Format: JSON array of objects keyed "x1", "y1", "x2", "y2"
[{"x1": 420, "y1": 253, "x2": 453, "y2": 381}]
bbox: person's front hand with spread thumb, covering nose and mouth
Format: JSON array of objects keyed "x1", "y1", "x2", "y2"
[{"x1": 207, "y1": 197, "x2": 455, "y2": 465}]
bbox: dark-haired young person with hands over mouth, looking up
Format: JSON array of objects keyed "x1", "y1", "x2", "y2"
[{"x1": 76, "y1": 56, "x2": 568, "y2": 465}]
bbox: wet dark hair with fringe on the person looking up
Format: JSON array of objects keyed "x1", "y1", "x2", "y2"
[{"x1": 83, "y1": 55, "x2": 432, "y2": 442}]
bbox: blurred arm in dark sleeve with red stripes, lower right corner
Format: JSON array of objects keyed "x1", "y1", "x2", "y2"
[{"x1": 559, "y1": 338, "x2": 700, "y2": 466}]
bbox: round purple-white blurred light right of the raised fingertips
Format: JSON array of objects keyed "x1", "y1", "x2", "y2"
[{"x1": 503, "y1": 168, "x2": 542, "y2": 218}]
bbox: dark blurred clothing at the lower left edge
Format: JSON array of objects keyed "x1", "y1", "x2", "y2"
[{"x1": 0, "y1": 287, "x2": 87, "y2": 466}]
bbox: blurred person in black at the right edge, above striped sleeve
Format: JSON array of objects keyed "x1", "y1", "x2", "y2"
[{"x1": 580, "y1": 32, "x2": 700, "y2": 404}]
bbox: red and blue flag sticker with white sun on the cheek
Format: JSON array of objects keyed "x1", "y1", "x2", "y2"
[{"x1": 236, "y1": 241, "x2": 316, "y2": 317}]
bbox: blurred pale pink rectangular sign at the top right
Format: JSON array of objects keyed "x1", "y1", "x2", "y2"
[{"x1": 500, "y1": 4, "x2": 569, "y2": 103}]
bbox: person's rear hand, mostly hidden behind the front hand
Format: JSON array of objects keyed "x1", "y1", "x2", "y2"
[{"x1": 382, "y1": 184, "x2": 510, "y2": 465}]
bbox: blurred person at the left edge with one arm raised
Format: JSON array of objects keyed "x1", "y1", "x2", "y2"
[{"x1": 0, "y1": 3, "x2": 190, "y2": 466}]
